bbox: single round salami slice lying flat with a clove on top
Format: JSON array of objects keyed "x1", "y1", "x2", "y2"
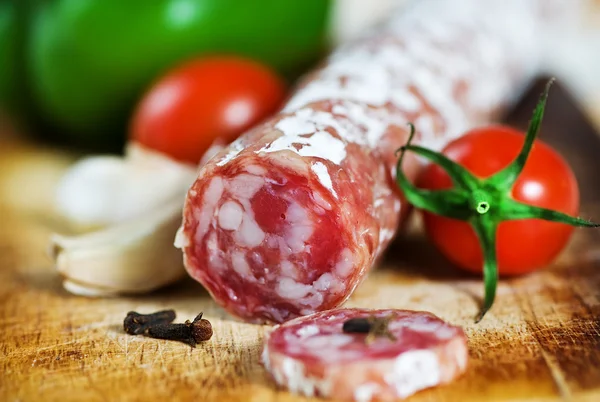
[{"x1": 262, "y1": 309, "x2": 468, "y2": 402}]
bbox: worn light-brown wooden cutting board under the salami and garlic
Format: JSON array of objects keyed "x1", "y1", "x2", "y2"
[{"x1": 0, "y1": 79, "x2": 600, "y2": 402}]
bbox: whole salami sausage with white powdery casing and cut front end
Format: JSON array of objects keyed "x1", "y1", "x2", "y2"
[{"x1": 176, "y1": 0, "x2": 564, "y2": 322}]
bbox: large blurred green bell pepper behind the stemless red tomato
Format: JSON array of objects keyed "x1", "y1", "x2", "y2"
[{"x1": 28, "y1": 0, "x2": 330, "y2": 145}]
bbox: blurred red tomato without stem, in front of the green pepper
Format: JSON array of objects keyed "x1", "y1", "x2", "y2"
[{"x1": 130, "y1": 56, "x2": 285, "y2": 164}]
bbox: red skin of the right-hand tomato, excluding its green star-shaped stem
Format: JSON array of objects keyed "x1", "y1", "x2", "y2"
[{"x1": 417, "y1": 126, "x2": 579, "y2": 275}]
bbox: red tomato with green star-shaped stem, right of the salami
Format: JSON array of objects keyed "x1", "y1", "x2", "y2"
[{"x1": 396, "y1": 79, "x2": 600, "y2": 322}]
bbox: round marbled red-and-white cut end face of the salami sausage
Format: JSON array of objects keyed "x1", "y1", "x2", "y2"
[{"x1": 177, "y1": 125, "x2": 390, "y2": 323}]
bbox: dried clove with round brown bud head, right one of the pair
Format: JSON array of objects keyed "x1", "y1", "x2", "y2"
[{"x1": 146, "y1": 313, "x2": 213, "y2": 347}]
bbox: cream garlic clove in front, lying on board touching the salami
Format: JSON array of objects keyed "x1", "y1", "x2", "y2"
[{"x1": 50, "y1": 192, "x2": 185, "y2": 296}]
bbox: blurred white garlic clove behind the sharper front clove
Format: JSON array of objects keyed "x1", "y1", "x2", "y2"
[{"x1": 55, "y1": 143, "x2": 196, "y2": 230}]
